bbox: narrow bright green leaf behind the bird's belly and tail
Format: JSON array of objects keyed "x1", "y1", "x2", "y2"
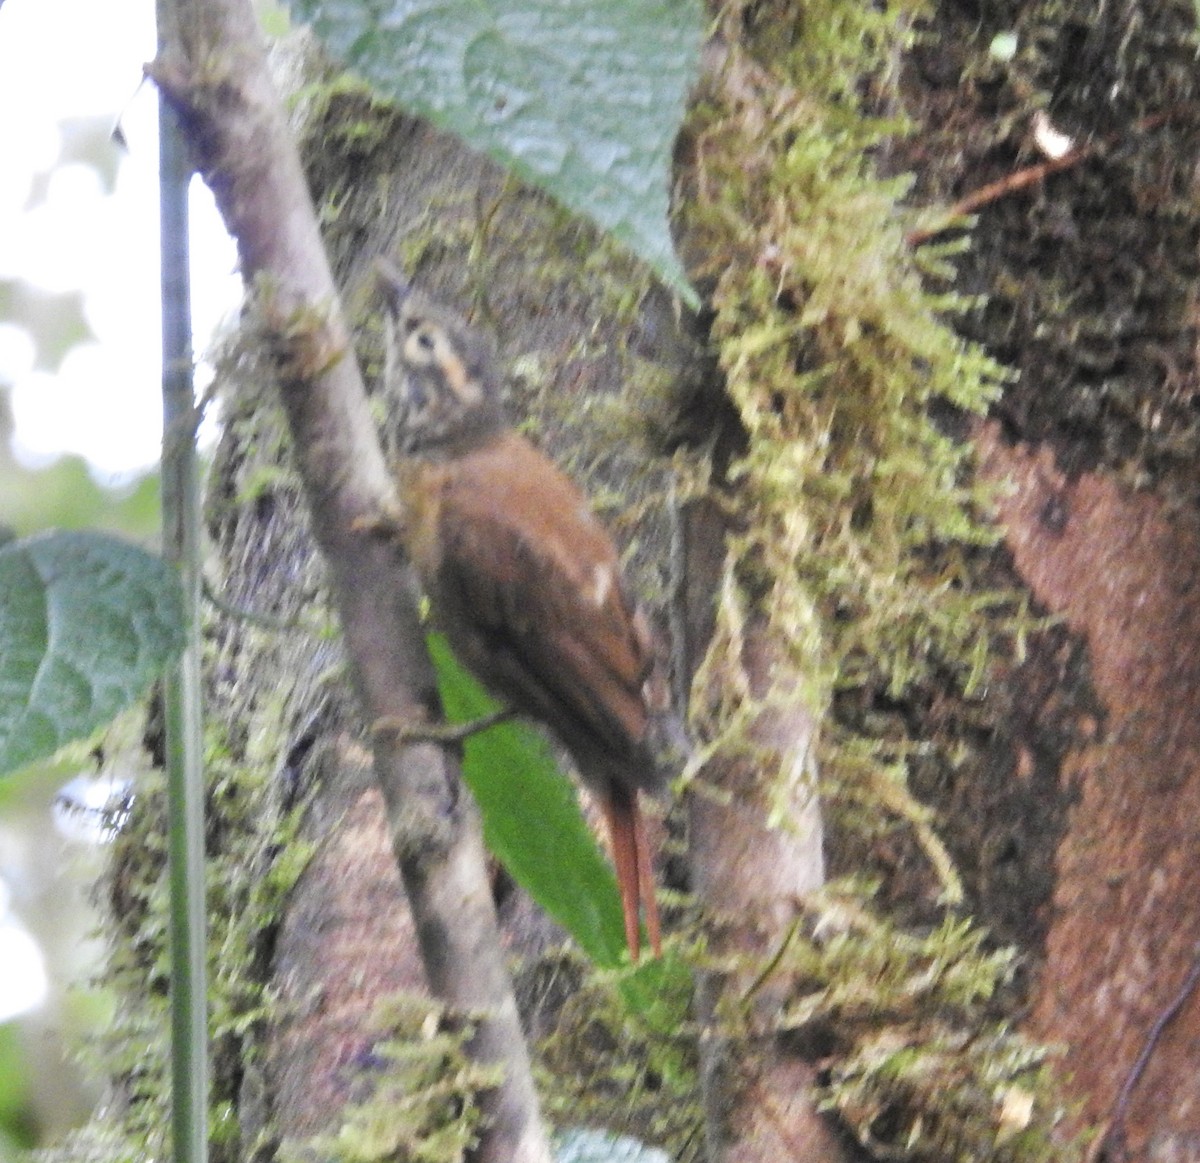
[{"x1": 428, "y1": 634, "x2": 625, "y2": 966}]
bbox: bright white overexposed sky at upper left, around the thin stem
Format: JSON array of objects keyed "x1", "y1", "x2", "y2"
[{"x1": 0, "y1": 0, "x2": 239, "y2": 478}]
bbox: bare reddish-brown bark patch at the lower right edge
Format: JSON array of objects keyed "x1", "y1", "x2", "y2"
[{"x1": 982, "y1": 427, "x2": 1200, "y2": 1158}]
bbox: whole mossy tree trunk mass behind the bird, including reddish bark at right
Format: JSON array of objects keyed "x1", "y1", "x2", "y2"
[{"x1": 70, "y1": 0, "x2": 1200, "y2": 1161}]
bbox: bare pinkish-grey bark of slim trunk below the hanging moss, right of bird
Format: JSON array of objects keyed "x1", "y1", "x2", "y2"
[{"x1": 680, "y1": 482, "x2": 846, "y2": 1163}]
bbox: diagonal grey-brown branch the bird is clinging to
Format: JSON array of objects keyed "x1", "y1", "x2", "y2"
[{"x1": 146, "y1": 0, "x2": 550, "y2": 1163}]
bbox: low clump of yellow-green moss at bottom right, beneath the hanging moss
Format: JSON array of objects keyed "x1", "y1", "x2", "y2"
[{"x1": 774, "y1": 885, "x2": 1082, "y2": 1163}]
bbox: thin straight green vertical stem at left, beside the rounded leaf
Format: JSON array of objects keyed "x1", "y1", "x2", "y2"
[{"x1": 157, "y1": 0, "x2": 208, "y2": 1163}]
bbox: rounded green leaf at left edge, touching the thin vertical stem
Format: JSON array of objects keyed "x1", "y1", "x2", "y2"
[{"x1": 0, "y1": 532, "x2": 184, "y2": 772}]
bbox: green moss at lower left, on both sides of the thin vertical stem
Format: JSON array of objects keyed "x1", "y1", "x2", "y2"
[{"x1": 72, "y1": 710, "x2": 311, "y2": 1159}]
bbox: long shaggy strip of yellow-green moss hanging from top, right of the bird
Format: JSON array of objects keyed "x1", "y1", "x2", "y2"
[{"x1": 689, "y1": 4, "x2": 1014, "y2": 864}]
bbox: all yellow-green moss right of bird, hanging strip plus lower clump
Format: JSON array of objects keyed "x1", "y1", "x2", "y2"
[{"x1": 685, "y1": 0, "x2": 1089, "y2": 1161}]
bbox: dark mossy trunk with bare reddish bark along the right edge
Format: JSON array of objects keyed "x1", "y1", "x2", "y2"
[{"x1": 910, "y1": 2, "x2": 1200, "y2": 1159}]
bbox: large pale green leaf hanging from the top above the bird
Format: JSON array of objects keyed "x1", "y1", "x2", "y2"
[{"x1": 293, "y1": 0, "x2": 703, "y2": 307}]
